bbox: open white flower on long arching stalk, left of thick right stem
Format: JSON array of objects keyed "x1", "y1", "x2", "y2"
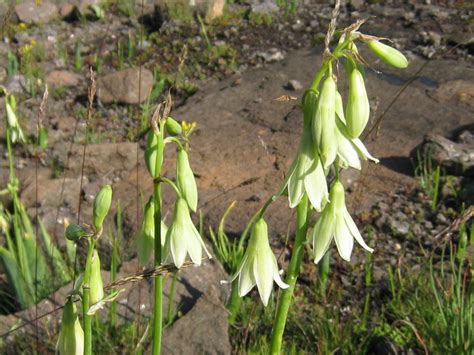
[{"x1": 228, "y1": 218, "x2": 289, "y2": 306}]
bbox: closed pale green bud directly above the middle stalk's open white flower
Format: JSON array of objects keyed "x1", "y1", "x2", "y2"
[{"x1": 176, "y1": 149, "x2": 198, "y2": 212}]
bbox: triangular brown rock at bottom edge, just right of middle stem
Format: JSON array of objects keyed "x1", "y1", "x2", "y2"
[{"x1": 163, "y1": 285, "x2": 232, "y2": 355}]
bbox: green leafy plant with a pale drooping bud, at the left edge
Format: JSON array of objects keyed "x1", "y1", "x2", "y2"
[{"x1": 0, "y1": 94, "x2": 71, "y2": 308}]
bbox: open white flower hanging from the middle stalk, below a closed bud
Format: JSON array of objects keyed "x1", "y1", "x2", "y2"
[{"x1": 164, "y1": 197, "x2": 211, "y2": 268}]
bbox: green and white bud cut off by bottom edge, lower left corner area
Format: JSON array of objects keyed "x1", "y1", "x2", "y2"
[{"x1": 56, "y1": 298, "x2": 84, "y2": 355}]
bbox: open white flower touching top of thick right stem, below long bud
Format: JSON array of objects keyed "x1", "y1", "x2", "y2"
[{"x1": 287, "y1": 131, "x2": 329, "y2": 211}]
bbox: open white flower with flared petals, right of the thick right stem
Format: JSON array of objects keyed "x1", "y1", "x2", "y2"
[{"x1": 312, "y1": 181, "x2": 373, "y2": 264}]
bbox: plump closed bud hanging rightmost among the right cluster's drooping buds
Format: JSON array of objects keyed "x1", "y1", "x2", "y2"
[{"x1": 346, "y1": 67, "x2": 370, "y2": 138}]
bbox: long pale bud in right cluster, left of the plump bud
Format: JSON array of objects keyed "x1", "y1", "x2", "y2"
[{"x1": 312, "y1": 75, "x2": 337, "y2": 169}]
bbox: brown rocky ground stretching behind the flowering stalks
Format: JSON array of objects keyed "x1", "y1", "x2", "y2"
[{"x1": 0, "y1": 0, "x2": 474, "y2": 353}]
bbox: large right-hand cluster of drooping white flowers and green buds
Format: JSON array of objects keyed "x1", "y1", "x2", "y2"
[{"x1": 233, "y1": 33, "x2": 408, "y2": 305}]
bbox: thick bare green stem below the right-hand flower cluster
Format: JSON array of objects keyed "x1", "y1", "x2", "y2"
[{"x1": 271, "y1": 194, "x2": 308, "y2": 354}]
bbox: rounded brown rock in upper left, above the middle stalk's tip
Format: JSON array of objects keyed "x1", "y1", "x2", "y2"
[{"x1": 97, "y1": 68, "x2": 153, "y2": 104}]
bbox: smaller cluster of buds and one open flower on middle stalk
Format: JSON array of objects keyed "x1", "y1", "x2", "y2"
[{"x1": 141, "y1": 117, "x2": 210, "y2": 268}]
